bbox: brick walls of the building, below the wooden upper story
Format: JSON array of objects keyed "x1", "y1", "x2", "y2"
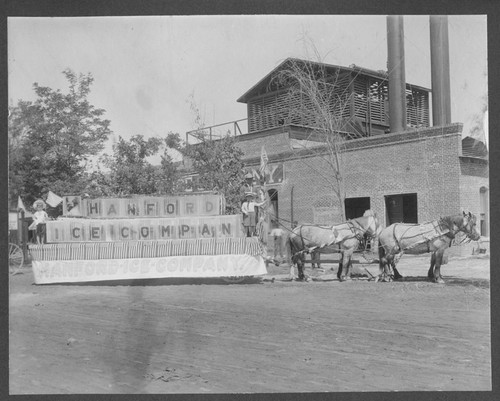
[{"x1": 238, "y1": 124, "x2": 488, "y2": 231}]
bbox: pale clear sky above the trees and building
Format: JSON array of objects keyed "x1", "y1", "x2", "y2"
[{"x1": 7, "y1": 15, "x2": 487, "y2": 152}]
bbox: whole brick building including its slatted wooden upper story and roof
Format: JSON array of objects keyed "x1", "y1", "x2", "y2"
[{"x1": 188, "y1": 60, "x2": 489, "y2": 235}]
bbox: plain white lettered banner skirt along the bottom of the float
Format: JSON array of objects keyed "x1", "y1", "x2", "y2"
[{"x1": 33, "y1": 254, "x2": 267, "y2": 284}]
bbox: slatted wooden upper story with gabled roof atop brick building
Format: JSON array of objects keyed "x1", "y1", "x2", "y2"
[{"x1": 237, "y1": 58, "x2": 430, "y2": 139}]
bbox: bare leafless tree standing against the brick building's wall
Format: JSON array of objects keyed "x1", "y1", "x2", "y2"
[{"x1": 272, "y1": 53, "x2": 350, "y2": 221}]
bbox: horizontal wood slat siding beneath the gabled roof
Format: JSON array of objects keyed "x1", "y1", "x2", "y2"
[{"x1": 248, "y1": 70, "x2": 430, "y2": 136}]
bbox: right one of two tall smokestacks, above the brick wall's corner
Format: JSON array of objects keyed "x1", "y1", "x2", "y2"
[{"x1": 429, "y1": 15, "x2": 451, "y2": 126}]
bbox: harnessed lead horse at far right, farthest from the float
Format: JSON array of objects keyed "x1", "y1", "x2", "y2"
[{"x1": 379, "y1": 212, "x2": 480, "y2": 283}]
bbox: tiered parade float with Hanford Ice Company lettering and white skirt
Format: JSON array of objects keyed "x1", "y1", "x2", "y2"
[{"x1": 30, "y1": 193, "x2": 267, "y2": 284}]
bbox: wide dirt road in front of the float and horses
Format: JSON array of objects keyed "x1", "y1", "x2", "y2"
[{"x1": 9, "y1": 256, "x2": 491, "y2": 394}]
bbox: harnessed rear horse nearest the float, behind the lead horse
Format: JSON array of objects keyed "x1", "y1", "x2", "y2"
[{"x1": 287, "y1": 213, "x2": 382, "y2": 281}]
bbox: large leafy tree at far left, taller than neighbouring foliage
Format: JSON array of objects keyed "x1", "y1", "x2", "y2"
[{"x1": 9, "y1": 69, "x2": 111, "y2": 206}]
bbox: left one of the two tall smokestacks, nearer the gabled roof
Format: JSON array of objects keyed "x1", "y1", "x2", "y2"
[{"x1": 387, "y1": 15, "x2": 406, "y2": 132}]
